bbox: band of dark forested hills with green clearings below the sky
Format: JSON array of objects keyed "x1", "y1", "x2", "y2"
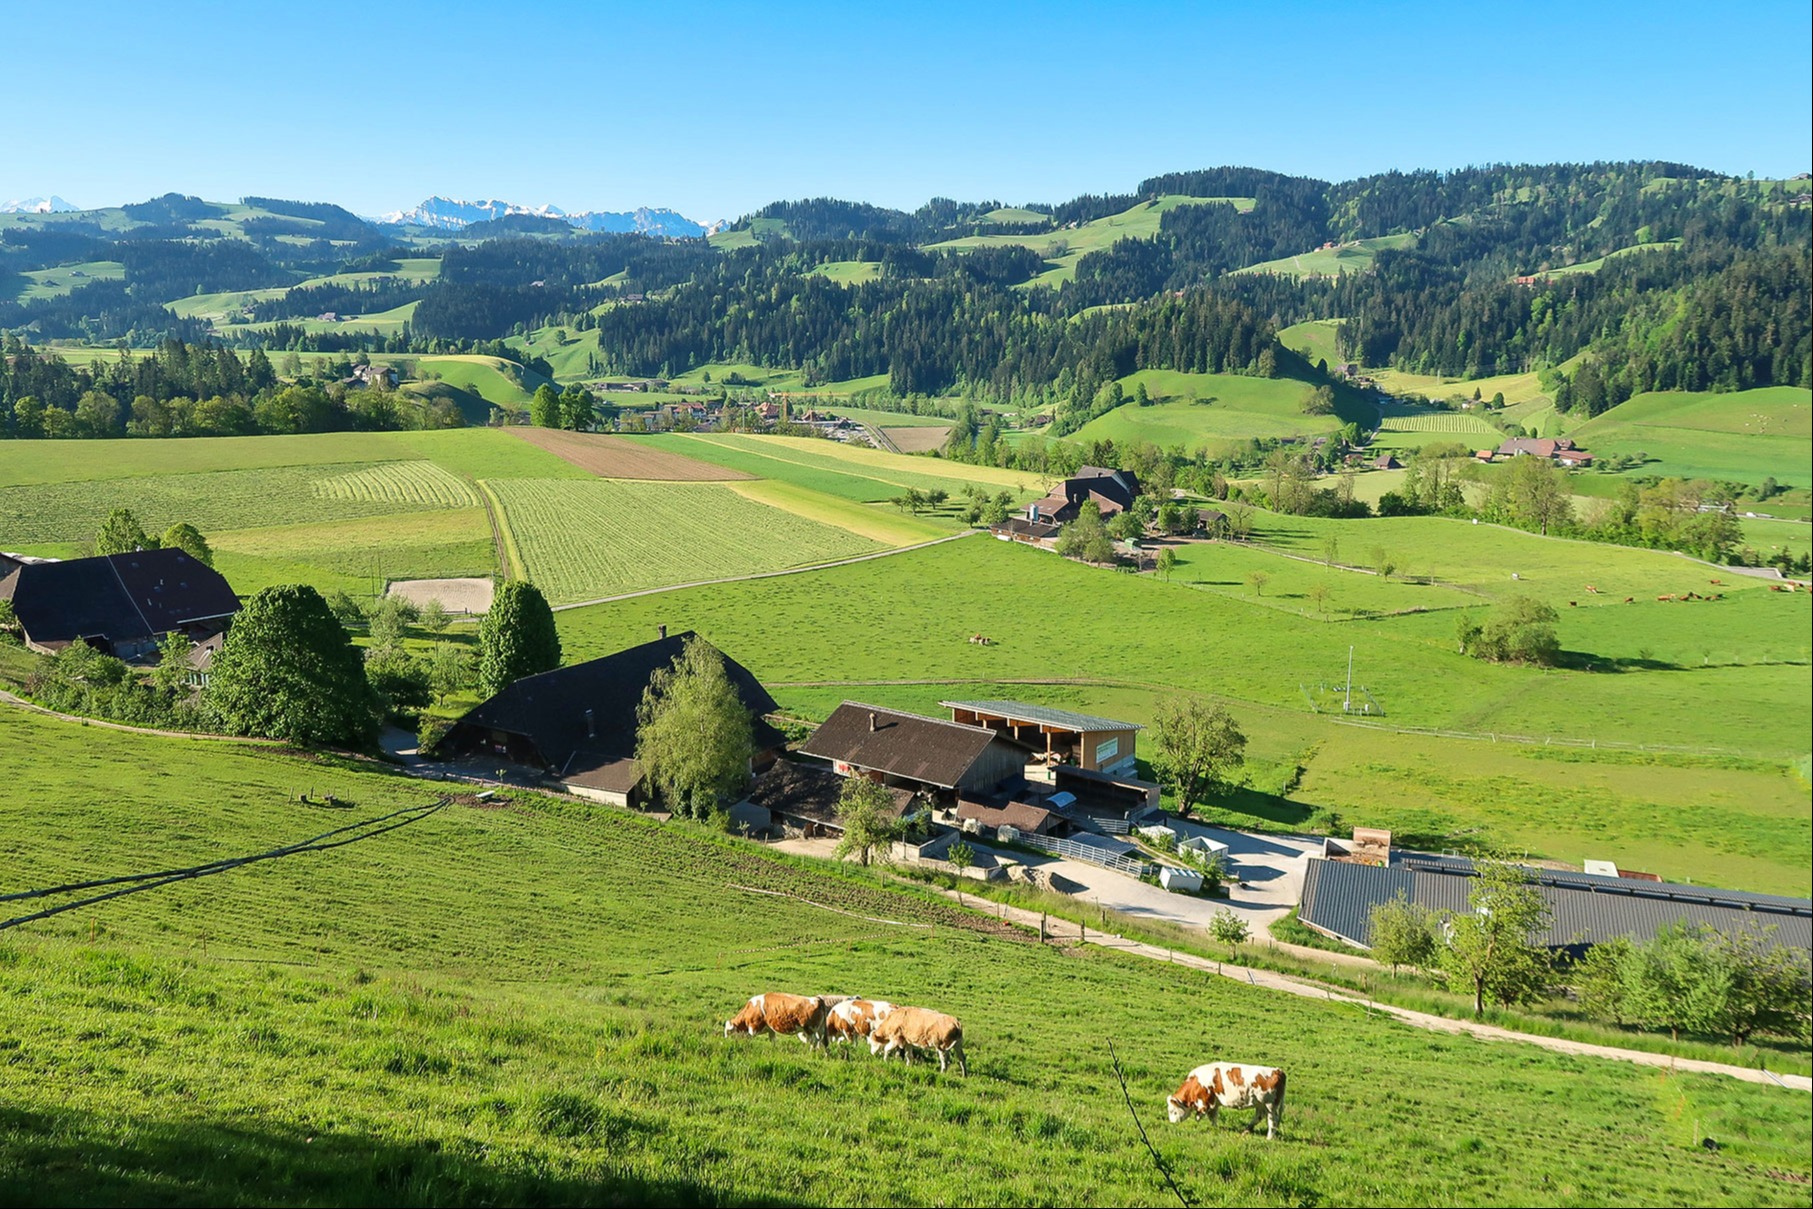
[{"x1": 0, "y1": 163, "x2": 1813, "y2": 429}]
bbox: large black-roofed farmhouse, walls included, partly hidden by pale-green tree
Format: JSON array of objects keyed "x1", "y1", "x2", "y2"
[{"x1": 441, "y1": 631, "x2": 787, "y2": 807}]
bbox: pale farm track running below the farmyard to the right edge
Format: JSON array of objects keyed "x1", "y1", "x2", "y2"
[{"x1": 943, "y1": 890, "x2": 1813, "y2": 1091}]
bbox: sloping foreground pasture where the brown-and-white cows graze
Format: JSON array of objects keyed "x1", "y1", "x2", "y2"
[{"x1": 0, "y1": 714, "x2": 1813, "y2": 1205}]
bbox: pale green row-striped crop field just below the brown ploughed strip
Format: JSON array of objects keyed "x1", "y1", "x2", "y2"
[{"x1": 486, "y1": 479, "x2": 879, "y2": 604}]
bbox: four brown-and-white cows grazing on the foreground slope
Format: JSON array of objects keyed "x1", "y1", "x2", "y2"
[{"x1": 723, "y1": 991, "x2": 1285, "y2": 1138}]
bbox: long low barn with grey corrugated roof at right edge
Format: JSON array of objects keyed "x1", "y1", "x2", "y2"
[{"x1": 1296, "y1": 850, "x2": 1813, "y2": 955}]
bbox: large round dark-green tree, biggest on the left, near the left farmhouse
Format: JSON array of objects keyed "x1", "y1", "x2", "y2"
[{"x1": 207, "y1": 584, "x2": 379, "y2": 747}]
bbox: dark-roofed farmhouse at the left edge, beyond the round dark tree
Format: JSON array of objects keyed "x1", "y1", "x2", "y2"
[{"x1": 0, "y1": 547, "x2": 239, "y2": 660}]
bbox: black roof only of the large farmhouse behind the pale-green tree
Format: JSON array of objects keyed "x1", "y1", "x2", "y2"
[{"x1": 457, "y1": 631, "x2": 787, "y2": 774}]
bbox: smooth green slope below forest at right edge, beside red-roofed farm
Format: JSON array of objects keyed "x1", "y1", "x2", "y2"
[{"x1": 1570, "y1": 386, "x2": 1813, "y2": 486}]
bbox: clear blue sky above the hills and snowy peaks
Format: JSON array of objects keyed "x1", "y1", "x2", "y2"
[{"x1": 0, "y1": 0, "x2": 1813, "y2": 221}]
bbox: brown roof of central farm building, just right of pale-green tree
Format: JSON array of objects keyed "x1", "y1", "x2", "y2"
[{"x1": 800, "y1": 701, "x2": 1032, "y2": 803}]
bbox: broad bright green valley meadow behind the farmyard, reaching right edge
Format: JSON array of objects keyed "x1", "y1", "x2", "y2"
[{"x1": 560, "y1": 532, "x2": 1813, "y2": 894}]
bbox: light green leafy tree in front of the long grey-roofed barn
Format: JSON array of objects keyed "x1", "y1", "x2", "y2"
[{"x1": 1440, "y1": 861, "x2": 1554, "y2": 1017}]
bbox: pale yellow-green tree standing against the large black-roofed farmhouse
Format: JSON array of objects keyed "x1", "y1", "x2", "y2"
[{"x1": 636, "y1": 638, "x2": 754, "y2": 819}]
